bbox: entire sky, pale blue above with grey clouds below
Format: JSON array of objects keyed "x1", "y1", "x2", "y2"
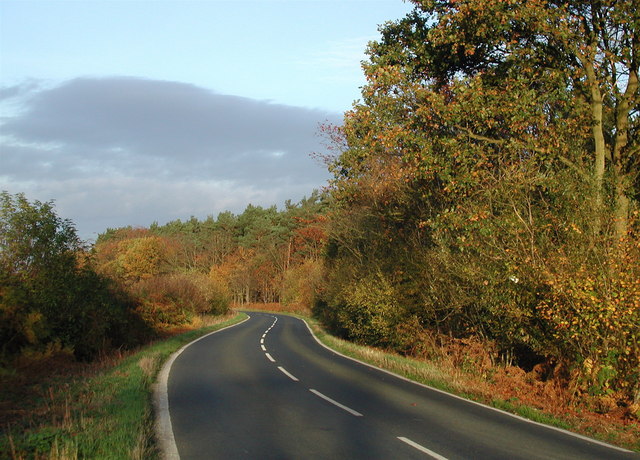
[{"x1": 0, "y1": 0, "x2": 411, "y2": 241}]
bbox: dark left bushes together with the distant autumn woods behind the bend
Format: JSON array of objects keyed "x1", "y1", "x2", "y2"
[{"x1": 0, "y1": 192, "x2": 326, "y2": 365}]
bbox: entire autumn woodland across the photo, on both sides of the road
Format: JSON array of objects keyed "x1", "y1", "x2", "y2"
[{"x1": 0, "y1": 0, "x2": 640, "y2": 414}]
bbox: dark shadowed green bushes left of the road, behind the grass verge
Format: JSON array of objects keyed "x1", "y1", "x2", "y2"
[{"x1": 0, "y1": 192, "x2": 147, "y2": 359}]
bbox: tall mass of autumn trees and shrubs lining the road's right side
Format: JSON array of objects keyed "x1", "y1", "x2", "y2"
[{"x1": 315, "y1": 0, "x2": 640, "y2": 414}]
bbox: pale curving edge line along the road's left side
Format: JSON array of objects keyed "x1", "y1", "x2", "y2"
[{"x1": 153, "y1": 313, "x2": 251, "y2": 460}]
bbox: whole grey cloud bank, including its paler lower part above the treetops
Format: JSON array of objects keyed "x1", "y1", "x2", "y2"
[{"x1": 0, "y1": 77, "x2": 340, "y2": 239}]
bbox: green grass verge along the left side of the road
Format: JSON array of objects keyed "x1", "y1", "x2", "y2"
[{"x1": 0, "y1": 314, "x2": 246, "y2": 460}]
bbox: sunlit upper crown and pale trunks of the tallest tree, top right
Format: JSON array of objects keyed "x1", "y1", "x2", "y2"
[{"x1": 365, "y1": 0, "x2": 640, "y2": 238}]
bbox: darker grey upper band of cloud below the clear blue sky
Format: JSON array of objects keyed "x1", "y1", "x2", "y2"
[{"x1": 0, "y1": 78, "x2": 338, "y2": 181}]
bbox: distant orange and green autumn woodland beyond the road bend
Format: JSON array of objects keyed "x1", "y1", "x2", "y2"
[{"x1": 94, "y1": 192, "x2": 326, "y2": 324}]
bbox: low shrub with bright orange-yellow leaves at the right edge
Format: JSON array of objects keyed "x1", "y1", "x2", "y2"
[{"x1": 538, "y1": 241, "x2": 640, "y2": 398}]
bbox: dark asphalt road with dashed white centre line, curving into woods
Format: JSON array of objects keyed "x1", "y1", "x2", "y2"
[{"x1": 168, "y1": 312, "x2": 640, "y2": 460}]
